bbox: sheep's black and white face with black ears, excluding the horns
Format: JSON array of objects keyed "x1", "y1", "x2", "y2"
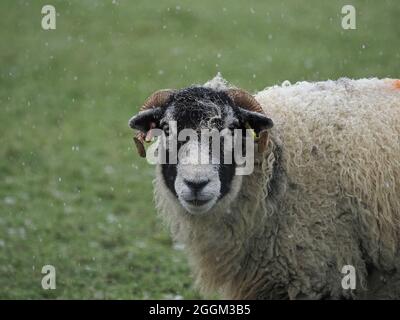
[{"x1": 130, "y1": 87, "x2": 272, "y2": 214}]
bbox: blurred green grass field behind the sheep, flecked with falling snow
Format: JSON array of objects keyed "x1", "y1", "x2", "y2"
[{"x1": 0, "y1": 0, "x2": 400, "y2": 299}]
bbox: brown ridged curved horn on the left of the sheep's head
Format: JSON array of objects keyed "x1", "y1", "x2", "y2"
[{"x1": 133, "y1": 89, "x2": 175, "y2": 158}]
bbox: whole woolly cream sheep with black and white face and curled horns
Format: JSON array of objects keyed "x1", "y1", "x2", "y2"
[{"x1": 130, "y1": 76, "x2": 400, "y2": 299}]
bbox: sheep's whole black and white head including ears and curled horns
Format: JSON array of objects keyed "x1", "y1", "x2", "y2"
[{"x1": 129, "y1": 86, "x2": 272, "y2": 214}]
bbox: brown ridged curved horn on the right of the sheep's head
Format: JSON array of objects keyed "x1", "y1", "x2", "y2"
[{"x1": 226, "y1": 89, "x2": 269, "y2": 153}]
